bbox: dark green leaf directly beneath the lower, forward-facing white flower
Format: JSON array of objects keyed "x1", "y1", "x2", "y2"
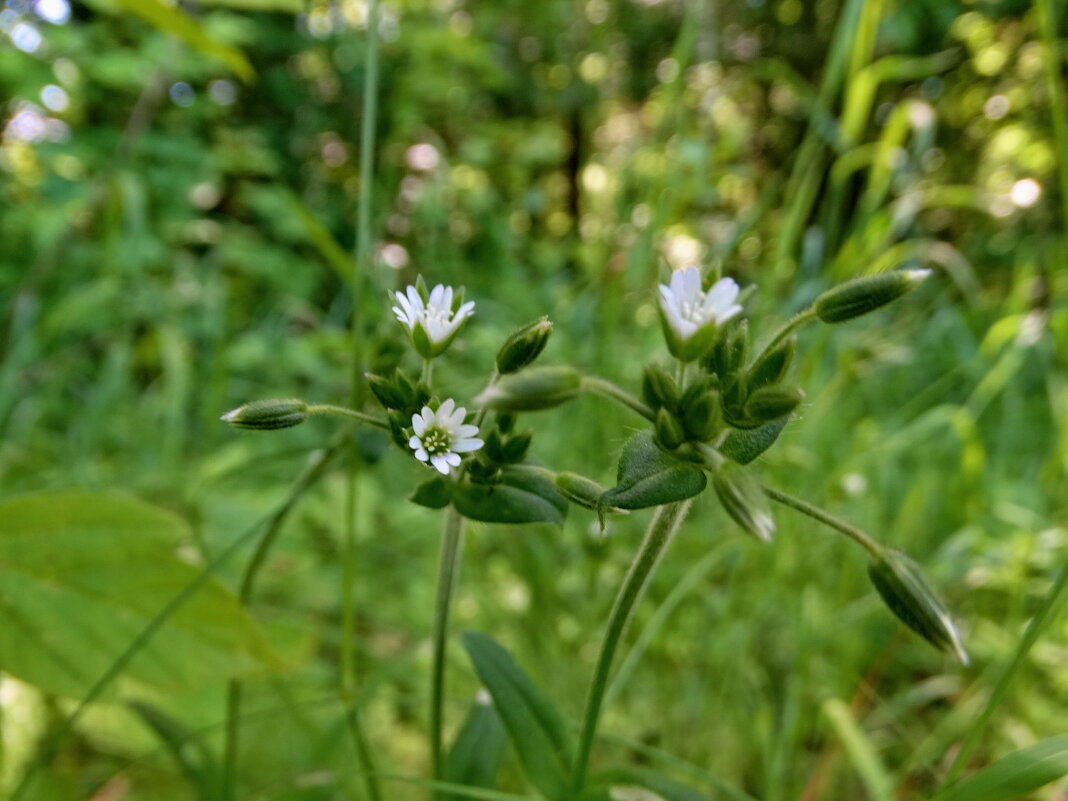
[{"x1": 452, "y1": 465, "x2": 567, "y2": 525}]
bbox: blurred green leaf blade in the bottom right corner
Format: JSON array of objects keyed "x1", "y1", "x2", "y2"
[{"x1": 937, "y1": 735, "x2": 1068, "y2": 801}]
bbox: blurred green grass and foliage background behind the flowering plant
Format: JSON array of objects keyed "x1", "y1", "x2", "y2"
[{"x1": 0, "y1": 0, "x2": 1068, "y2": 801}]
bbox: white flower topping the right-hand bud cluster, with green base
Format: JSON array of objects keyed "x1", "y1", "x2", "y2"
[{"x1": 660, "y1": 266, "x2": 741, "y2": 362}]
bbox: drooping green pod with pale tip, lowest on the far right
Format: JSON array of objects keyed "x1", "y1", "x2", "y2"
[{"x1": 868, "y1": 550, "x2": 968, "y2": 664}]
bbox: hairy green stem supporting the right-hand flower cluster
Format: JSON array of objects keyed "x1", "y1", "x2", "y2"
[{"x1": 571, "y1": 500, "x2": 693, "y2": 796}]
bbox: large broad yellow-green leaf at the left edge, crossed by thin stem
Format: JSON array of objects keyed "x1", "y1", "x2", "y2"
[{"x1": 0, "y1": 492, "x2": 277, "y2": 697}]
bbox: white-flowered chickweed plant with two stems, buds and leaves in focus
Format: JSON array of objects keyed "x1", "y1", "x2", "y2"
[{"x1": 222, "y1": 266, "x2": 968, "y2": 801}]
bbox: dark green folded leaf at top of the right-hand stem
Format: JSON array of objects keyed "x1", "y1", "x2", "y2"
[{"x1": 600, "y1": 431, "x2": 708, "y2": 509}]
